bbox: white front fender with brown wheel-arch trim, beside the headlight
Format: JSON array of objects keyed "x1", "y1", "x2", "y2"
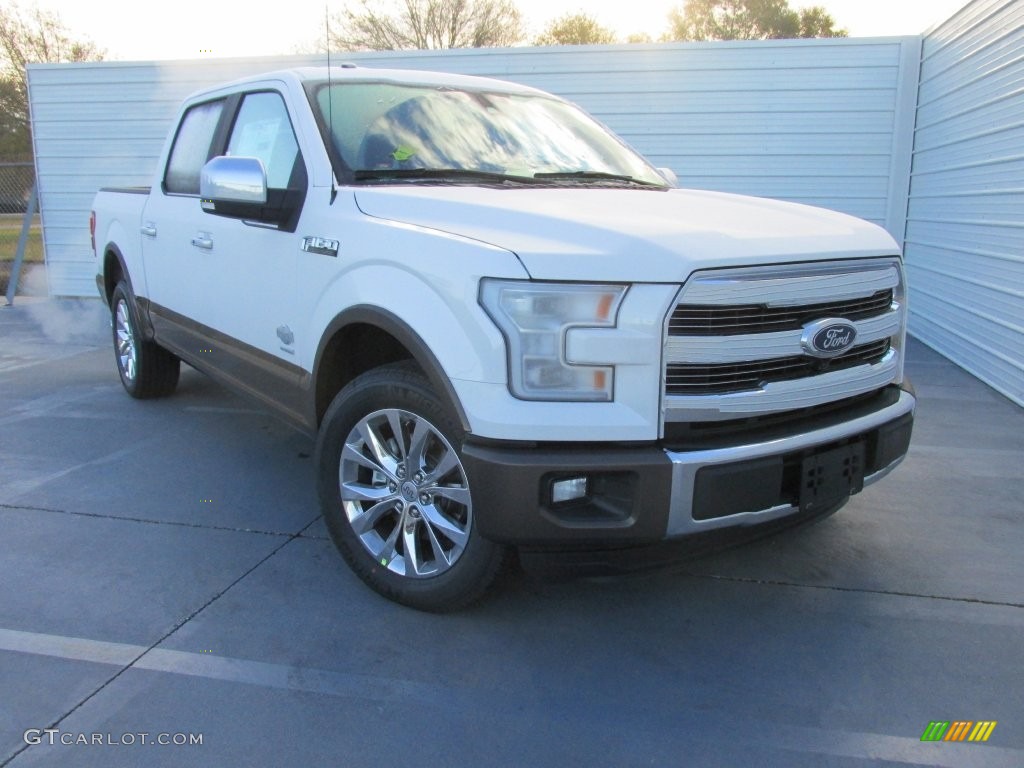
[{"x1": 297, "y1": 217, "x2": 528, "y2": 431}]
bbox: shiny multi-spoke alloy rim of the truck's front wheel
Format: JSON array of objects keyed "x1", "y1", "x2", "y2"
[{"x1": 339, "y1": 409, "x2": 473, "y2": 579}]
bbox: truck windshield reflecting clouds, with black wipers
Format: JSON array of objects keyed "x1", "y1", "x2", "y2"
[{"x1": 312, "y1": 82, "x2": 666, "y2": 187}]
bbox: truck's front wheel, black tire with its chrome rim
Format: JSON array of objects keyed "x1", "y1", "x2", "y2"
[{"x1": 315, "y1": 364, "x2": 505, "y2": 612}]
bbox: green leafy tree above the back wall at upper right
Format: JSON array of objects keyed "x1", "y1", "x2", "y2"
[{"x1": 666, "y1": 0, "x2": 847, "y2": 40}]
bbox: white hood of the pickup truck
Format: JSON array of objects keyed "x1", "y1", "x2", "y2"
[{"x1": 355, "y1": 185, "x2": 898, "y2": 283}]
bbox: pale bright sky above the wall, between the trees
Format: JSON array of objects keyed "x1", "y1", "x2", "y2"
[{"x1": 36, "y1": 0, "x2": 968, "y2": 60}]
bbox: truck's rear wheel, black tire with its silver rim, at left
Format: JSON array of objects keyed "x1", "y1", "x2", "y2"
[{"x1": 111, "y1": 281, "x2": 181, "y2": 399}]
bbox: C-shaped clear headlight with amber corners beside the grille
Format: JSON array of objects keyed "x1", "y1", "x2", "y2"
[{"x1": 480, "y1": 280, "x2": 626, "y2": 401}]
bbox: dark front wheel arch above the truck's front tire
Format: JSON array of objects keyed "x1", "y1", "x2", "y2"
[{"x1": 311, "y1": 305, "x2": 469, "y2": 432}]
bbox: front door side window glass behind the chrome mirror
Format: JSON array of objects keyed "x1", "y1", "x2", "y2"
[{"x1": 227, "y1": 92, "x2": 302, "y2": 189}]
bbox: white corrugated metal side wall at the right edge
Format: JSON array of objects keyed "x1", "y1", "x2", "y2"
[{"x1": 905, "y1": 0, "x2": 1024, "y2": 406}]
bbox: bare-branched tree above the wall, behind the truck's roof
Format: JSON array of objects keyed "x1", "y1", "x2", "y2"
[{"x1": 331, "y1": 0, "x2": 523, "y2": 50}]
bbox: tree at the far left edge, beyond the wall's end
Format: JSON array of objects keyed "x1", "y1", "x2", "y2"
[{"x1": 0, "y1": 3, "x2": 103, "y2": 160}]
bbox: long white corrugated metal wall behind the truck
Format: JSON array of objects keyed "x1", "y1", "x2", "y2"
[{"x1": 29, "y1": 37, "x2": 921, "y2": 296}]
